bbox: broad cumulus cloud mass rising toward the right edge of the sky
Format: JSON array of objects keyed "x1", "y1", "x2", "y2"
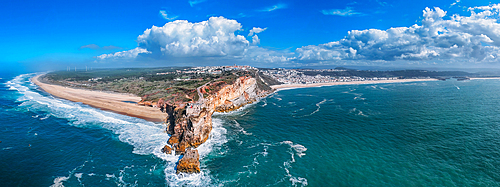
[{"x1": 296, "y1": 5, "x2": 500, "y2": 62}]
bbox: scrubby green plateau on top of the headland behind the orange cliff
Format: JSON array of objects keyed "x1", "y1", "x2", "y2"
[{"x1": 41, "y1": 67, "x2": 270, "y2": 103}]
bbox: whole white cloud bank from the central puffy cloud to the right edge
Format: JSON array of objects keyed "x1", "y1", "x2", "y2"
[{"x1": 97, "y1": 4, "x2": 500, "y2": 66}]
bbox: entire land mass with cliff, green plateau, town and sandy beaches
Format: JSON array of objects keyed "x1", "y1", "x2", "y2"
[{"x1": 32, "y1": 66, "x2": 480, "y2": 173}]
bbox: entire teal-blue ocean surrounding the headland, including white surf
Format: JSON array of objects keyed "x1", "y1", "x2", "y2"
[{"x1": 0, "y1": 74, "x2": 500, "y2": 187}]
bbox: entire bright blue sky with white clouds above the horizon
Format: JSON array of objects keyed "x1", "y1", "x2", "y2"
[{"x1": 0, "y1": 0, "x2": 500, "y2": 70}]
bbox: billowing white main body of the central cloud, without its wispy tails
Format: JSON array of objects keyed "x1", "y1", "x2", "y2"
[{"x1": 137, "y1": 17, "x2": 249, "y2": 57}]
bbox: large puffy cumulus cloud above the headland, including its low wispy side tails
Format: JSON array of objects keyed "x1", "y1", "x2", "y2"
[{"x1": 98, "y1": 17, "x2": 290, "y2": 62}]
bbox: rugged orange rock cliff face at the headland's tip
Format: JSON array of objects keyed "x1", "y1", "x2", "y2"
[{"x1": 156, "y1": 77, "x2": 273, "y2": 173}]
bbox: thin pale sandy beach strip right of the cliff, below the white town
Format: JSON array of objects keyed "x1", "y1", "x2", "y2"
[{"x1": 271, "y1": 79, "x2": 437, "y2": 90}]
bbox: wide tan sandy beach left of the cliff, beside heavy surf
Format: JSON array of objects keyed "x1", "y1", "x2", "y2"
[{"x1": 31, "y1": 75, "x2": 167, "y2": 122}]
